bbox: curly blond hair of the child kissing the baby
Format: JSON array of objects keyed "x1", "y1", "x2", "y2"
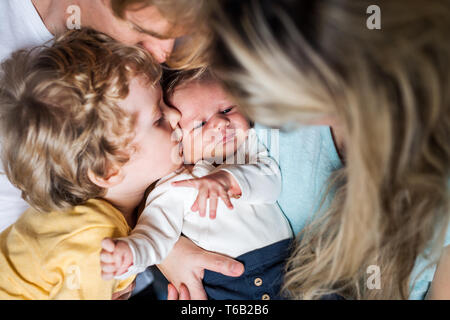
[{"x1": 0, "y1": 30, "x2": 161, "y2": 212}]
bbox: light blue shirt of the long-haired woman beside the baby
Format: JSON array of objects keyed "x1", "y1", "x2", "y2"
[{"x1": 255, "y1": 124, "x2": 450, "y2": 299}]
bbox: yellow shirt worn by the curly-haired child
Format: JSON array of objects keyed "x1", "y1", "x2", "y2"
[{"x1": 0, "y1": 199, "x2": 135, "y2": 299}]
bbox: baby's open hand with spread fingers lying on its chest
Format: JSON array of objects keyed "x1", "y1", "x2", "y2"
[{"x1": 172, "y1": 170, "x2": 241, "y2": 219}]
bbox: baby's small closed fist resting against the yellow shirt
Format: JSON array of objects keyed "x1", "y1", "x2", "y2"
[{"x1": 100, "y1": 238, "x2": 133, "y2": 280}]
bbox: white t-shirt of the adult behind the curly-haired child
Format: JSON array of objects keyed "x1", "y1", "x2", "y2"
[{"x1": 0, "y1": 0, "x2": 53, "y2": 232}]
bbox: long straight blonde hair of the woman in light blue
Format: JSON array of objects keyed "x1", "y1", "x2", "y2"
[{"x1": 212, "y1": 0, "x2": 450, "y2": 299}]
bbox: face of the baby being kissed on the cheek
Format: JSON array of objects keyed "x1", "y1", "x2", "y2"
[{"x1": 170, "y1": 81, "x2": 249, "y2": 163}]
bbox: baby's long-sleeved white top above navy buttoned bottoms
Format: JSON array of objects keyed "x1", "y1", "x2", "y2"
[{"x1": 117, "y1": 130, "x2": 293, "y2": 279}]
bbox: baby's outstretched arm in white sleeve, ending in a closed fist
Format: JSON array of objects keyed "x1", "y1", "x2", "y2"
[{"x1": 100, "y1": 185, "x2": 188, "y2": 280}]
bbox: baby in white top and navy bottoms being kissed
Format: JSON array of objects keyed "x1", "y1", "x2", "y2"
[{"x1": 101, "y1": 72, "x2": 292, "y2": 300}]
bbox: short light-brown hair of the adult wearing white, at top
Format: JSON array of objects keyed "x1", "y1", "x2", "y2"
[{"x1": 111, "y1": 0, "x2": 211, "y2": 70}]
